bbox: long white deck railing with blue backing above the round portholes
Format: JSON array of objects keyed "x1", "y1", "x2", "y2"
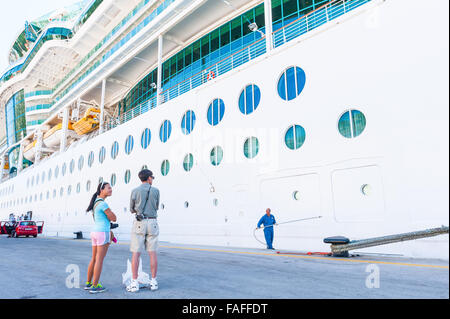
[{"x1": 105, "y1": 0, "x2": 372, "y2": 131}]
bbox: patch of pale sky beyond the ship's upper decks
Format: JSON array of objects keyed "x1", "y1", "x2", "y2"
[{"x1": 0, "y1": 0, "x2": 78, "y2": 72}]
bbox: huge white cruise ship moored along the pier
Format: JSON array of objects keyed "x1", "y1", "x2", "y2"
[{"x1": 0, "y1": 0, "x2": 449, "y2": 260}]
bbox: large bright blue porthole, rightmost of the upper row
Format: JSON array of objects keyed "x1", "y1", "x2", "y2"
[{"x1": 278, "y1": 67, "x2": 306, "y2": 101}]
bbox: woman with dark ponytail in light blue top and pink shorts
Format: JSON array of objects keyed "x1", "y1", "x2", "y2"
[{"x1": 84, "y1": 183, "x2": 117, "y2": 294}]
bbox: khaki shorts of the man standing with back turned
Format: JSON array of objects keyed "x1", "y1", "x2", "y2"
[{"x1": 130, "y1": 219, "x2": 159, "y2": 253}]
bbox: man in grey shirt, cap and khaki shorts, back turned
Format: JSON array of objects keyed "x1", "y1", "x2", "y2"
[{"x1": 127, "y1": 170, "x2": 159, "y2": 292}]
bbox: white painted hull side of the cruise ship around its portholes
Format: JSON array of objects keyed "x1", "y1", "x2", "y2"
[{"x1": 0, "y1": 0, "x2": 449, "y2": 259}]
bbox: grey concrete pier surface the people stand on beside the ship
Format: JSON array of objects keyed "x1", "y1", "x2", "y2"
[{"x1": 0, "y1": 236, "x2": 449, "y2": 299}]
